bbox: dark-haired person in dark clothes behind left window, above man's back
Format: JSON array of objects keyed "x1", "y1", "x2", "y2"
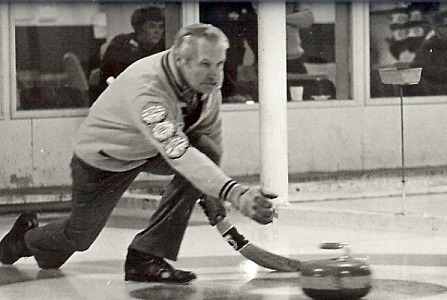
[{"x1": 92, "y1": 7, "x2": 166, "y2": 101}]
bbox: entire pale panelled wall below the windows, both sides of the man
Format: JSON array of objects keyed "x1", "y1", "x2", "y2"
[{"x1": 0, "y1": 104, "x2": 447, "y2": 189}]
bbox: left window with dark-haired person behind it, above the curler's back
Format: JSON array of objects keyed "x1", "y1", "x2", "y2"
[{"x1": 10, "y1": 3, "x2": 180, "y2": 112}]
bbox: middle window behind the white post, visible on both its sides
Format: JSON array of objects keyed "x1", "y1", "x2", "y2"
[{"x1": 200, "y1": 2, "x2": 350, "y2": 103}]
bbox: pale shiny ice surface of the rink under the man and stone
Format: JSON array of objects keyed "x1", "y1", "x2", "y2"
[{"x1": 0, "y1": 191, "x2": 447, "y2": 300}]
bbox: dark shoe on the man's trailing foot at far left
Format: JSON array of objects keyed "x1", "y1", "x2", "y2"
[{"x1": 0, "y1": 213, "x2": 39, "y2": 265}]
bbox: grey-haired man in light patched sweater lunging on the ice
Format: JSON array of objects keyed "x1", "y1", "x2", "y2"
[{"x1": 0, "y1": 24, "x2": 275, "y2": 283}]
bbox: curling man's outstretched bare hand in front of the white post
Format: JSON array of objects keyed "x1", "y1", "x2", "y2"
[{"x1": 229, "y1": 185, "x2": 277, "y2": 224}]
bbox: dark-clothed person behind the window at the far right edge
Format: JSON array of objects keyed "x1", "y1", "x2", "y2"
[{"x1": 411, "y1": 11, "x2": 447, "y2": 95}]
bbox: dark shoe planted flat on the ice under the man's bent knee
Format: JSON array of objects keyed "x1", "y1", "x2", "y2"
[{"x1": 124, "y1": 249, "x2": 197, "y2": 283}]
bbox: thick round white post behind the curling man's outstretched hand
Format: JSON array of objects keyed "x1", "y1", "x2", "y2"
[{"x1": 258, "y1": 1, "x2": 289, "y2": 206}]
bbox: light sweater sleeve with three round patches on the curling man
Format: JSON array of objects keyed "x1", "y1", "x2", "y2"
[{"x1": 129, "y1": 89, "x2": 231, "y2": 197}]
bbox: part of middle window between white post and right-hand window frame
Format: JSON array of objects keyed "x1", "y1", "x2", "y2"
[{"x1": 286, "y1": 1, "x2": 351, "y2": 101}]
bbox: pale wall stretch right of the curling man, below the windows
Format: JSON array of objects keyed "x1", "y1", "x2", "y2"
[{"x1": 223, "y1": 104, "x2": 447, "y2": 175}]
